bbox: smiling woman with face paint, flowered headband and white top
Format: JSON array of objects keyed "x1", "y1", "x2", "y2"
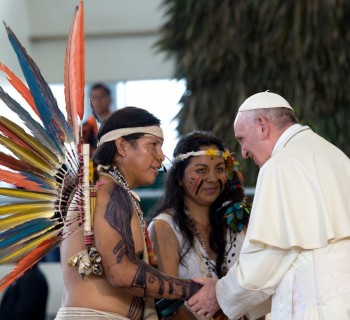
[{"x1": 149, "y1": 131, "x2": 249, "y2": 319}]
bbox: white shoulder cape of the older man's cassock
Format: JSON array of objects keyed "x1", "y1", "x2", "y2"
[{"x1": 245, "y1": 126, "x2": 350, "y2": 252}]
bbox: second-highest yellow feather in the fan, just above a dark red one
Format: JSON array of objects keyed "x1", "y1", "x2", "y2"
[{"x1": 0, "y1": 135, "x2": 56, "y2": 176}]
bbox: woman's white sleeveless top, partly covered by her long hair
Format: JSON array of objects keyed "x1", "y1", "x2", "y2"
[{"x1": 149, "y1": 213, "x2": 244, "y2": 279}]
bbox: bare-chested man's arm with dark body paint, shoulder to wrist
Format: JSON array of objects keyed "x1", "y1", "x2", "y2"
[{"x1": 95, "y1": 186, "x2": 201, "y2": 300}]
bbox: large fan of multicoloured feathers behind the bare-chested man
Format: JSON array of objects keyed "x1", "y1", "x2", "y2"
[{"x1": 0, "y1": 0, "x2": 93, "y2": 291}]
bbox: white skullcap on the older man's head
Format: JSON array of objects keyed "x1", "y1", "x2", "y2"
[{"x1": 238, "y1": 91, "x2": 293, "y2": 112}]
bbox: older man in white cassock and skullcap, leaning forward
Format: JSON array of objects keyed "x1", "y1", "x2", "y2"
[{"x1": 188, "y1": 92, "x2": 350, "y2": 320}]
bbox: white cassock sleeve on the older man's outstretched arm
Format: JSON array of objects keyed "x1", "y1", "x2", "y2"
[{"x1": 216, "y1": 246, "x2": 300, "y2": 319}]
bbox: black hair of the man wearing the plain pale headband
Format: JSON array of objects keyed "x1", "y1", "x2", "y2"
[{"x1": 92, "y1": 107, "x2": 160, "y2": 165}]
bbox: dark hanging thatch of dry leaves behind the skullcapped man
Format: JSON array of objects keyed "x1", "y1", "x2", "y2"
[{"x1": 156, "y1": 0, "x2": 350, "y2": 185}]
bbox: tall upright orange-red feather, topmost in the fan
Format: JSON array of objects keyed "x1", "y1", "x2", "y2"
[{"x1": 64, "y1": 0, "x2": 85, "y2": 143}]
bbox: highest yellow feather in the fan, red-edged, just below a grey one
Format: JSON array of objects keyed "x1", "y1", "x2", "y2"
[{"x1": 0, "y1": 116, "x2": 60, "y2": 166}]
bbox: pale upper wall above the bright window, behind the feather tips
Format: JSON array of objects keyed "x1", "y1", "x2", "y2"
[{"x1": 0, "y1": 0, "x2": 173, "y2": 84}]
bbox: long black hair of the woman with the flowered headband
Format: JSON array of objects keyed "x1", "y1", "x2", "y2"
[{"x1": 152, "y1": 131, "x2": 231, "y2": 276}]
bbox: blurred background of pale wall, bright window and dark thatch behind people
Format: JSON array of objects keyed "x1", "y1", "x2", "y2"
[{"x1": 0, "y1": 0, "x2": 350, "y2": 318}]
